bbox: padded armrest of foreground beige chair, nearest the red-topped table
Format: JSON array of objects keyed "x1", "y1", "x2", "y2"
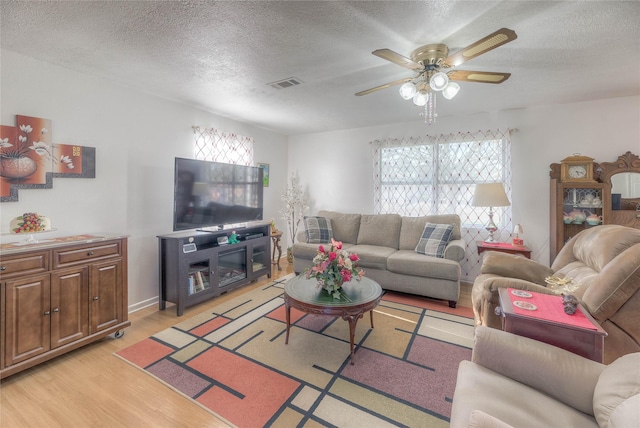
[{"x1": 471, "y1": 326, "x2": 606, "y2": 415}]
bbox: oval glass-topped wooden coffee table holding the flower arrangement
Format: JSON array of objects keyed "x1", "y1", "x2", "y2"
[{"x1": 284, "y1": 274, "x2": 382, "y2": 364}]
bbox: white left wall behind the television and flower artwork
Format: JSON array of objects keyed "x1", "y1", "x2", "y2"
[{"x1": 0, "y1": 50, "x2": 287, "y2": 309}]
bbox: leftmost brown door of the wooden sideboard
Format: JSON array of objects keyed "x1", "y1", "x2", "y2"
[{"x1": 4, "y1": 273, "x2": 51, "y2": 366}]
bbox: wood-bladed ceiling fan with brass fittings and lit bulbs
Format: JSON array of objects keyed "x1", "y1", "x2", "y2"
[{"x1": 356, "y1": 28, "x2": 518, "y2": 106}]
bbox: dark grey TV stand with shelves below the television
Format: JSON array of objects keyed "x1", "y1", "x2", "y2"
[{"x1": 158, "y1": 223, "x2": 271, "y2": 316}]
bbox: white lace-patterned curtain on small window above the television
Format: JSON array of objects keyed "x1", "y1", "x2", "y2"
[{"x1": 193, "y1": 126, "x2": 254, "y2": 166}]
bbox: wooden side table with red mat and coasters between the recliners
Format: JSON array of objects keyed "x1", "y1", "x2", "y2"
[{"x1": 498, "y1": 288, "x2": 607, "y2": 363}]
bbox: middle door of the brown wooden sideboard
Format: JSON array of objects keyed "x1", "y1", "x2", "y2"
[{"x1": 51, "y1": 266, "x2": 89, "y2": 349}]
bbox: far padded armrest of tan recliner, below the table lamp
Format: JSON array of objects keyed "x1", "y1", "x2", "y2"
[{"x1": 480, "y1": 251, "x2": 553, "y2": 285}]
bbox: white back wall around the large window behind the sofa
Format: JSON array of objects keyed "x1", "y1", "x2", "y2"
[{"x1": 289, "y1": 97, "x2": 640, "y2": 280}]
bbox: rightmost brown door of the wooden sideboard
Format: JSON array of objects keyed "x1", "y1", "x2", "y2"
[{"x1": 89, "y1": 259, "x2": 123, "y2": 334}]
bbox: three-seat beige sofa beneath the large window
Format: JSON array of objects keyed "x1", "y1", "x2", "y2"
[{"x1": 292, "y1": 211, "x2": 466, "y2": 308}]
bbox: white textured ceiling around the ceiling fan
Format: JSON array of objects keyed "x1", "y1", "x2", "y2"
[{"x1": 0, "y1": 0, "x2": 640, "y2": 135}]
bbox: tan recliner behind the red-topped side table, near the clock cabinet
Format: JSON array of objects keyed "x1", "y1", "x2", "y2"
[{"x1": 471, "y1": 225, "x2": 640, "y2": 363}]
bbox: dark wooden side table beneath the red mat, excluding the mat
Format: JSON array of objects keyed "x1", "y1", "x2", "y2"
[{"x1": 496, "y1": 288, "x2": 607, "y2": 363}]
